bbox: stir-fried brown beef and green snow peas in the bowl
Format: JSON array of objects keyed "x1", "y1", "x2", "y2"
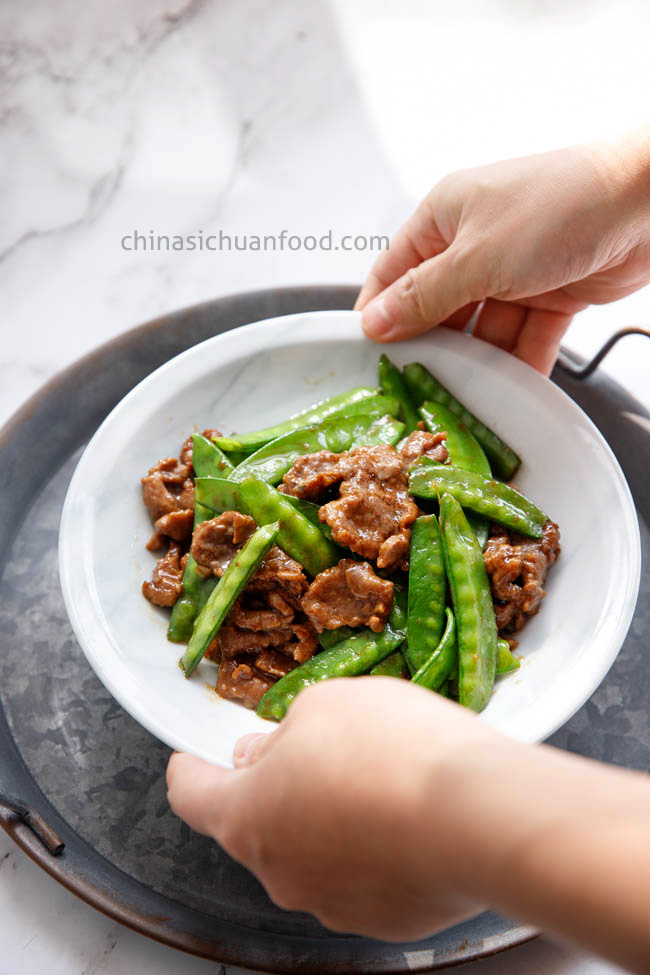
[{"x1": 142, "y1": 355, "x2": 560, "y2": 721}]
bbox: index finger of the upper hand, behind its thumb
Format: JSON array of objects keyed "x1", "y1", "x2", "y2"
[{"x1": 354, "y1": 197, "x2": 448, "y2": 311}]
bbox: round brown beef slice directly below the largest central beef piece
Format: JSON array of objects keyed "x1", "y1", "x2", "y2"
[{"x1": 301, "y1": 559, "x2": 393, "y2": 633}]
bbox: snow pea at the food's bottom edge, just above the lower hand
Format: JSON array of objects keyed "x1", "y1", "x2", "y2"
[{"x1": 257, "y1": 589, "x2": 406, "y2": 721}]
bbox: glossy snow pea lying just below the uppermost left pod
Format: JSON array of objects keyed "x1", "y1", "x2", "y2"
[{"x1": 229, "y1": 413, "x2": 404, "y2": 484}]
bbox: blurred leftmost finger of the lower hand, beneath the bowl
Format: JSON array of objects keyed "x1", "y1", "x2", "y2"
[{"x1": 167, "y1": 752, "x2": 233, "y2": 835}]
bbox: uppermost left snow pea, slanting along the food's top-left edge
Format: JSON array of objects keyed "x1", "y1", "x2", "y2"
[{"x1": 215, "y1": 386, "x2": 399, "y2": 454}]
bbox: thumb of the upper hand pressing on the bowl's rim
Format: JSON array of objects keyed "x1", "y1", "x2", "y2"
[{"x1": 361, "y1": 242, "x2": 486, "y2": 342}]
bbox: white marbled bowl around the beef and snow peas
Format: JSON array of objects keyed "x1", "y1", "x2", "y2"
[{"x1": 59, "y1": 312, "x2": 641, "y2": 766}]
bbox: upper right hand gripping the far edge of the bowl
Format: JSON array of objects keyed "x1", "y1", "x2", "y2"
[{"x1": 355, "y1": 136, "x2": 650, "y2": 374}]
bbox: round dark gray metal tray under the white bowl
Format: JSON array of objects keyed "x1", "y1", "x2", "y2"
[{"x1": 0, "y1": 288, "x2": 650, "y2": 975}]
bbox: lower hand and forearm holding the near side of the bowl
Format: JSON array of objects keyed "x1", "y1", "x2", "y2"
[{"x1": 167, "y1": 677, "x2": 650, "y2": 971}]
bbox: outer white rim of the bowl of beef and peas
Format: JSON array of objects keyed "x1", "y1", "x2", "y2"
[{"x1": 58, "y1": 310, "x2": 641, "y2": 762}]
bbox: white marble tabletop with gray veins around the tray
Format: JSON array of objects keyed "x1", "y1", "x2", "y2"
[{"x1": 0, "y1": 0, "x2": 650, "y2": 975}]
